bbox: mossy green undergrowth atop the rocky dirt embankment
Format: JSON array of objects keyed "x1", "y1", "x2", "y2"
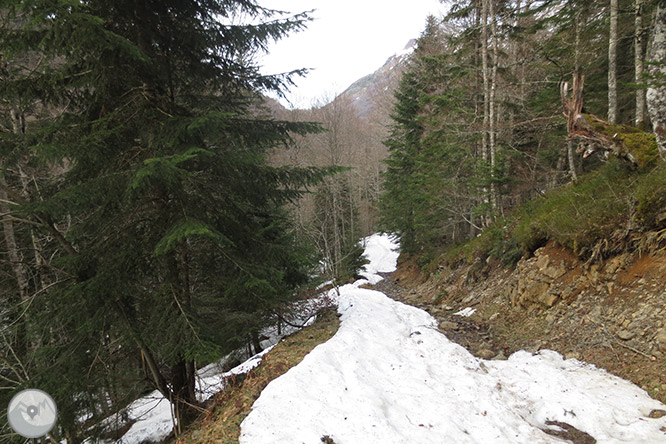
[{"x1": 443, "y1": 158, "x2": 666, "y2": 265}]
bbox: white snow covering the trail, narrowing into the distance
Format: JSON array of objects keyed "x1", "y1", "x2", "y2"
[{"x1": 240, "y1": 235, "x2": 666, "y2": 444}]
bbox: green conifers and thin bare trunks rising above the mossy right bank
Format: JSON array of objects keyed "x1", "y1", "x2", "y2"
[{"x1": 380, "y1": 0, "x2": 654, "y2": 254}]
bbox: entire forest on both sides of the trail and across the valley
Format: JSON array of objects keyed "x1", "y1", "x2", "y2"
[{"x1": 0, "y1": 0, "x2": 666, "y2": 443}]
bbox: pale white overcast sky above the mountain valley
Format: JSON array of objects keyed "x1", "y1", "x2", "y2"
[{"x1": 254, "y1": 0, "x2": 444, "y2": 108}]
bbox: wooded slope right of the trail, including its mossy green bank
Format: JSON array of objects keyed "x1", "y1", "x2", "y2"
[{"x1": 380, "y1": 0, "x2": 666, "y2": 261}]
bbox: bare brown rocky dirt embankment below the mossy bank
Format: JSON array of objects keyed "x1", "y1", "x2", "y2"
[{"x1": 379, "y1": 243, "x2": 666, "y2": 402}]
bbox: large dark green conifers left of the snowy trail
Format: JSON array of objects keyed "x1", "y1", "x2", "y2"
[{"x1": 0, "y1": 0, "x2": 326, "y2": 442}]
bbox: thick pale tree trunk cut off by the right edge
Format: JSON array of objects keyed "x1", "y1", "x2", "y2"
[{"x1": 646, "y1": 5, "x2": 666, "y2": 161}]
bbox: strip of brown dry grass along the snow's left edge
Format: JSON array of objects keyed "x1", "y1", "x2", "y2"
[{"x1": 176, "y1": 308, "x2": 340, "y2": 444}]
